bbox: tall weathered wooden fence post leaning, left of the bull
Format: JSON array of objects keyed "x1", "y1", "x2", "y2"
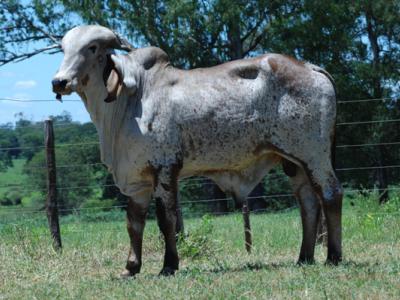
[{"x1": 44, "y1": 120, "x2": 62, "y2": 250}]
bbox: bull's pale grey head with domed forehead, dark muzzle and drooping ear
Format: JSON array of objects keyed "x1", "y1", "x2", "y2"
[{"x1": 52, "y1": 25, "x2": 133, "y2": 102}]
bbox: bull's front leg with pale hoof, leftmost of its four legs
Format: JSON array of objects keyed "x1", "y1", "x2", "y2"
[{"x1": 121, "y1": 190, "x2": 151, "y2": 277}]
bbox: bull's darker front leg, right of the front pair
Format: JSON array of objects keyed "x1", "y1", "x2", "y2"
[{"x1": 154, "y1": 165, "x2": 179, "y2": 275}]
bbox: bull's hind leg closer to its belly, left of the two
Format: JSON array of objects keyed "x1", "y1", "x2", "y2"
[{"x1": 282, "y1": 160, "x2": 321, "y2": 264}]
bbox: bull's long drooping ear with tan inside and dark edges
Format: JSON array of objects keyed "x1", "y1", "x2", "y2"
[{"x1": 103, "y1": 55, "x2": 122, "y2": 102}]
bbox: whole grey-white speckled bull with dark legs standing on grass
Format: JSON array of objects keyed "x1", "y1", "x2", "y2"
[{"x1": 52, "y1": 25, "x2": 342, "y2": 276}]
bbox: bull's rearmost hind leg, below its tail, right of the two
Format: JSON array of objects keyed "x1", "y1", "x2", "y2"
[{"x1": 307, "y1": 163, "x2": 343, "y2": 265}]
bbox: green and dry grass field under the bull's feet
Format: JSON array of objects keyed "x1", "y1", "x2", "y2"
[{"x1": 0, "y1": 199, "x2": 400, "y2": 299}]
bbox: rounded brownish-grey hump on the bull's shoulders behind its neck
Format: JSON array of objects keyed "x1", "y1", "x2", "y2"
[{"x1": 129, "y1": 47, "x2": 170, "y2": 70}]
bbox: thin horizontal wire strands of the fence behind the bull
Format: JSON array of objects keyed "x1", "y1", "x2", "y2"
[{"x1": 0, "y1": 98, "x2": 400, "y2": 229}]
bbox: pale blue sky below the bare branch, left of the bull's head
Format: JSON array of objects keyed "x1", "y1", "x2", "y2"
[{"x1": 0, "y1": 53, "x2": 90, "y2": 124}]
